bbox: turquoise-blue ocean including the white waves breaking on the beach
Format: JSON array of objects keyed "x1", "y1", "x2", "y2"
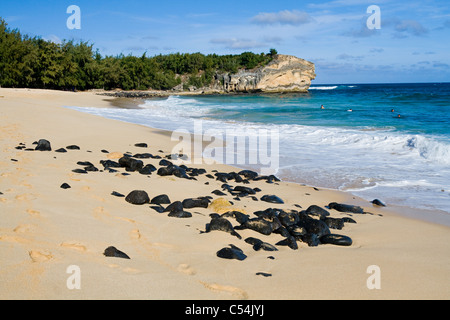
[{"x1": 69, "y1": 83, "x2": 450, "y2": 220}]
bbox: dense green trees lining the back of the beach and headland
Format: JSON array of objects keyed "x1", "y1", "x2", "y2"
[{"x1": 0, "y1": 18, "x2": 277, "y2": 90}]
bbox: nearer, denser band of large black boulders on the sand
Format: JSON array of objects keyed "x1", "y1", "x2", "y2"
[{"x1": 122, "y1": 190, "x2": 365, "y2": 260}]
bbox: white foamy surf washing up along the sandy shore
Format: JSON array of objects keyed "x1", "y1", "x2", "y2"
[{"x1": 66, "y1": 94, "x2": 450, "y2": 212}]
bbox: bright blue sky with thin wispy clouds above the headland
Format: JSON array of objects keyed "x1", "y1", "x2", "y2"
[{"x1": 0, "y1": 0, "x2": 450, "y2": 84}]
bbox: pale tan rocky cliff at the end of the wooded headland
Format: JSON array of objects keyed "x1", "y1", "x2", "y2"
[{"x1": 211, "y1": 55, "x2": 316, "y2": 93}]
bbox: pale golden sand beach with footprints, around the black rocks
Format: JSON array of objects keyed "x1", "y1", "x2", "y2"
[{"x1": 0, "y1": 89, "x2": 450, "y2": 300}]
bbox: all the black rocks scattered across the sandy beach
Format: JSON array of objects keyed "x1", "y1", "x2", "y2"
[{"x1": 16, "y1": 139, "x2": 384, "y2": 261}]
